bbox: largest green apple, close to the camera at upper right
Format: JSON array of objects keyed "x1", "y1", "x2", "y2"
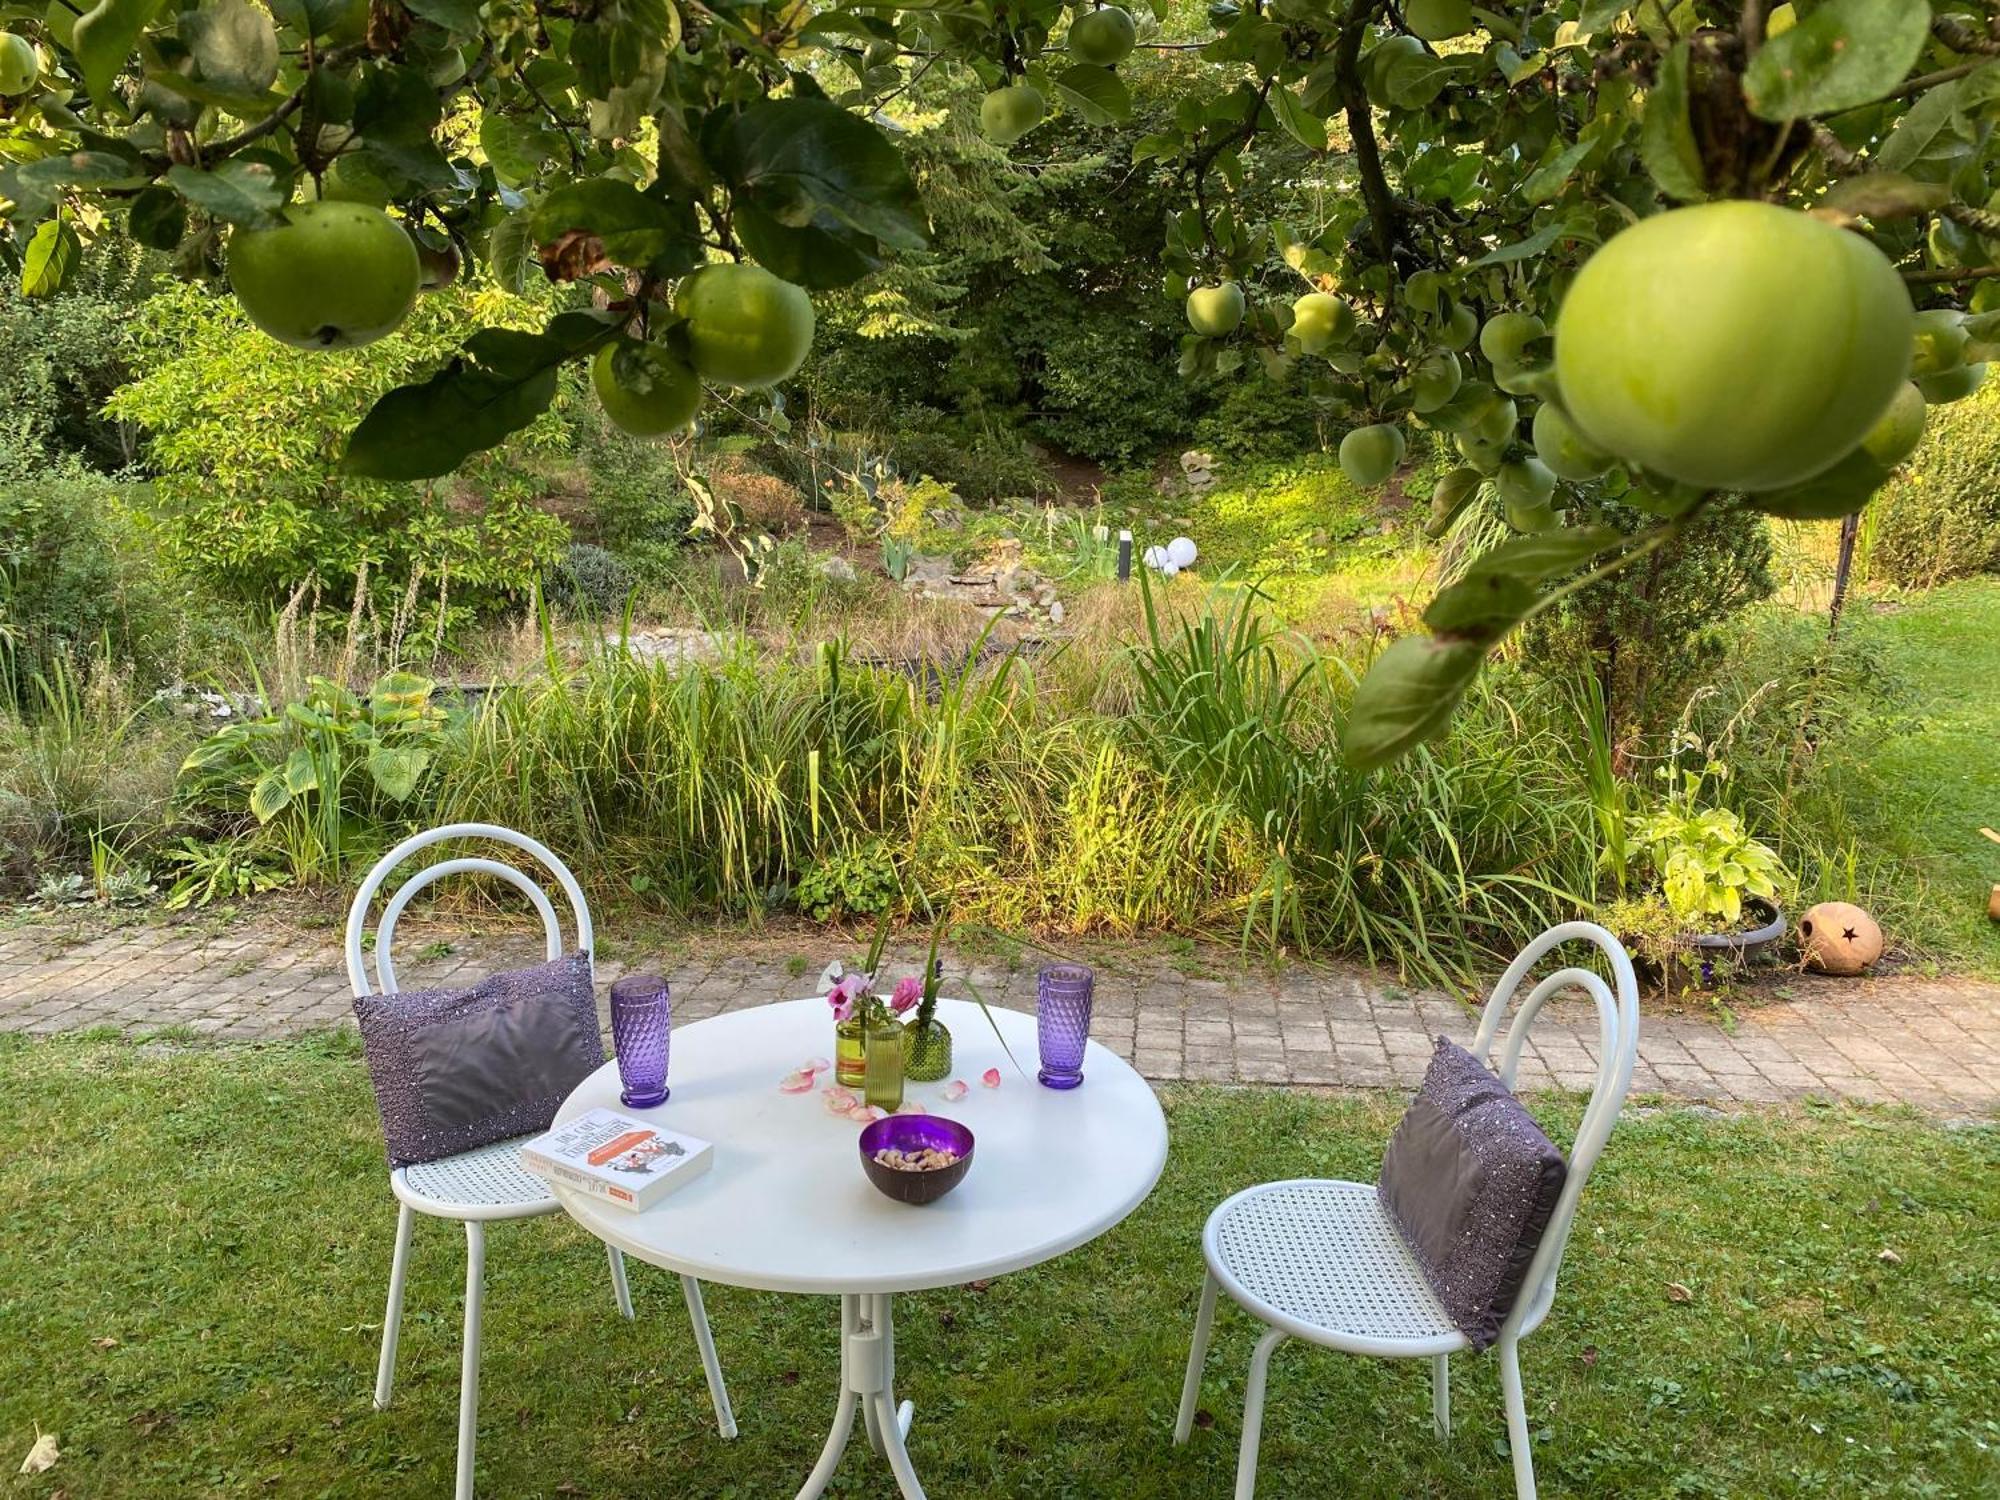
[{"x1": 1556, "y1": 200, "x2": 1914, "y2": 492}]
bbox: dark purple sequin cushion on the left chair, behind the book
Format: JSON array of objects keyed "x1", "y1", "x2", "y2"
[{"x1": 354, "y1": 952, "x2": 604, "y2": 1166}]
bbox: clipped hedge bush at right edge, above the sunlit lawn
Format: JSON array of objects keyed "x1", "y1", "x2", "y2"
[{"x1": 1862, "y1": 380, "x2": 2000, "y2": 588}]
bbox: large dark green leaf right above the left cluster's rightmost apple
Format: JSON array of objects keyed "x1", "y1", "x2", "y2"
[{"x1": 708, "y1": 98, "x2": 930, "y2": 250}]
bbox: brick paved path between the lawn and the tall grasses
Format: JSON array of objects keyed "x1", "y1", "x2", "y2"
[{"x1": 0, "y1": 918, "x2": 2000, "y2": 1114}]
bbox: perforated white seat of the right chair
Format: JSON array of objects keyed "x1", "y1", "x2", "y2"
[{"x1": 1202, "y1": 1180, "x2": 1470, "y2": 1356}]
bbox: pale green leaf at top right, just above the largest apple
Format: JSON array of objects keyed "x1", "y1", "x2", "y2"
[{"x1": 1744, "y1": 0, "x2": 1930, "y2": 120}]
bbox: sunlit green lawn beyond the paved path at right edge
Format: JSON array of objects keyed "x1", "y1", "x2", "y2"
[{"x1": 1840, "y1": 578, "x2": 2000, "y2": 974}]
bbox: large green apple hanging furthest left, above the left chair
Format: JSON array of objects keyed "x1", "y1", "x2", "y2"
[{"x1": 230, "y1": 202, "x2": 424, "y2": 348}]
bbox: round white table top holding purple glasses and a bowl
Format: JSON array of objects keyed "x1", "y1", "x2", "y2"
[{"x1": 554, "y1": 1000, "x2": 1166, "y2": 1292}]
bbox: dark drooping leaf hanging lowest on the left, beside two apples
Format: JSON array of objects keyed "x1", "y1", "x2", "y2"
[{"x1": 342, "y1": 312, "x2": 618, "y2": 480}]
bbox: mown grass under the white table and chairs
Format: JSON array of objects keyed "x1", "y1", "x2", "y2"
[{"x1": 0, "y1": 1034, "x2": 2000, "y2": 1500}]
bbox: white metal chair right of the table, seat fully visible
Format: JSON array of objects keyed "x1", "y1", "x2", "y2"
[{"x1": 1174, "y1": 922, "x2": 1638, "y2": 1500}]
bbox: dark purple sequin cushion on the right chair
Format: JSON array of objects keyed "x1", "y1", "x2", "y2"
[{"x1": 1376, "y1": 1036, "x2": 1568, "y2": 1348}]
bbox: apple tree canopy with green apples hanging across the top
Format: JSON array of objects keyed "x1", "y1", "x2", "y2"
[{"x1": 0, "y1": 0, "x2": 2000, "y2": 766}]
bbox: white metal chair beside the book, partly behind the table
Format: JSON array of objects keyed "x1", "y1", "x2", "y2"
[{"x1": 346, "y1": 822, "x2": 736, "y2": 1500}]
